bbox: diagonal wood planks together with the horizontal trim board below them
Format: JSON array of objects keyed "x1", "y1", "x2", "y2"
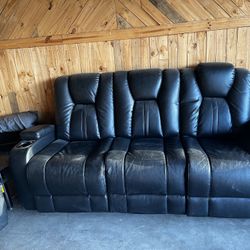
[{"x1": 0, "y1": 0, "x2": 250, "y2": 49}]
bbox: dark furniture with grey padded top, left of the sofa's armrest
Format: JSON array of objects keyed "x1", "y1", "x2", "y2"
[{"x1": 0, "y1": 112, "x2": 38, "y2": 208}]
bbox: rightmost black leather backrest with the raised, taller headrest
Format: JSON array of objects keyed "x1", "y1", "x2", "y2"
[{"x1": 180, "y1": 63, "x2": 250, "y2": 136}]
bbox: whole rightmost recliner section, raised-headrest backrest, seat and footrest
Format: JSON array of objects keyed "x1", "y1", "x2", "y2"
[{"x1": 181, "y1": 63, "x2": 250, "y2": 217}]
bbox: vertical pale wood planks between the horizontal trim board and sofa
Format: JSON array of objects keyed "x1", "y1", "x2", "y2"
[{"x1": 0, "y1": 27, "x2": 250, "y2": 122}]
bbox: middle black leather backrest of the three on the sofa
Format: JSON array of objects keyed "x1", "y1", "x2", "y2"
[{"x1": 114, "y1": 69, "x2": 180, "y2": 137}]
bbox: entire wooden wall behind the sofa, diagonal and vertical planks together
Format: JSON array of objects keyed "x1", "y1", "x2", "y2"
[{"x1": 0, "y1": 0, "x2": 250, "y2": 122}]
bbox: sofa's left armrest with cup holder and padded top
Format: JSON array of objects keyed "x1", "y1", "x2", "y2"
[{"x1": 10, "y1": 129, "x2": 55, "y2": 209}]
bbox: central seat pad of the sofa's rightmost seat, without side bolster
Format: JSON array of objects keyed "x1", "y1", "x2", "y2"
[{"x1": 200, "y1": 138, "x2": 250, "y2": 198}]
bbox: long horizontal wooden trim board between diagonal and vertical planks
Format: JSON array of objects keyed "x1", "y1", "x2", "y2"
[{"x1": 0, "y1": 17, "x2": 250, "y2": 49}]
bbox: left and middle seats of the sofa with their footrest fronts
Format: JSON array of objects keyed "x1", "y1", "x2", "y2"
[{"x1": 27, "y1": 137, "x2": 185, "y2": 213}]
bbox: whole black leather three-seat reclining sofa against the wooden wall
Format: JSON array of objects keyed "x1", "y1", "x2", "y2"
[{"x1": 11, "y1": 63, "x2": 250, "y2": 217}]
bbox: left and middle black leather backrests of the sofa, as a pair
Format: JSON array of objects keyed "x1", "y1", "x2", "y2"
[{"x1": 55, "y1": 69, "x2": 180, "y2": 140}]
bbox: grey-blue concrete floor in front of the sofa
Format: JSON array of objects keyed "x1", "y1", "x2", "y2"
[{"x1": 0, "y1": 207, "x2": 250, "y2": 250}]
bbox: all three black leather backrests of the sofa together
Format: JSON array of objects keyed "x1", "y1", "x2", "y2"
[{"x1": 55, "y1": 63, "x2": 250, "y2": 141}]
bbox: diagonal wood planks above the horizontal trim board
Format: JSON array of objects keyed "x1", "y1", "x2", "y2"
[{"x1": 0, "y1": 0, "x2": 250, "y2": 42}]
